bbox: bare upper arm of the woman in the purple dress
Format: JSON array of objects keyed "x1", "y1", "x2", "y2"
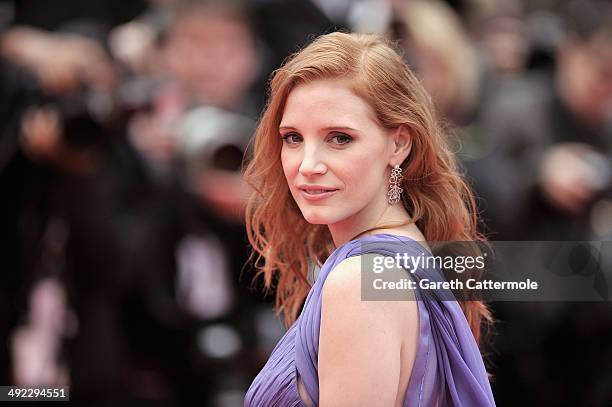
[{"x1": 318, "y1": 257, "x2": 418, "y2": 407}]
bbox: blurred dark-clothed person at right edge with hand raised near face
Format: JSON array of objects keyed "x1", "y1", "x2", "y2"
[{"x1": 471, "y1": 0, "x2": 612, "y2": 405}]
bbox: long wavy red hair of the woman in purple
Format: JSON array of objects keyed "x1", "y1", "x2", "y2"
[{"x1": 245, "y1": 32, "x2": 491, "y2": 342}]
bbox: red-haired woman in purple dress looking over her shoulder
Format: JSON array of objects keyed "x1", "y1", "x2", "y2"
[{"x1": 245, "y1": 33, "x2": 494, "y2": 406}]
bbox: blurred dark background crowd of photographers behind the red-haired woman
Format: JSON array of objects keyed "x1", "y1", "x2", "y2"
[{"x1": 0, "y1": 0, "x2": 612, "y2": 407}]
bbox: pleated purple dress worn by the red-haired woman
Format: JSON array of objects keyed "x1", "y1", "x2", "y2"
[{"x1": 244, "y1": 234, "x2": 495, "y2": 407}]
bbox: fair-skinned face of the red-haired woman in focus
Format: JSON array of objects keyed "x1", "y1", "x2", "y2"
[{"x1": 279, "y1": 80, "x2": 393, "y2": 225}]
